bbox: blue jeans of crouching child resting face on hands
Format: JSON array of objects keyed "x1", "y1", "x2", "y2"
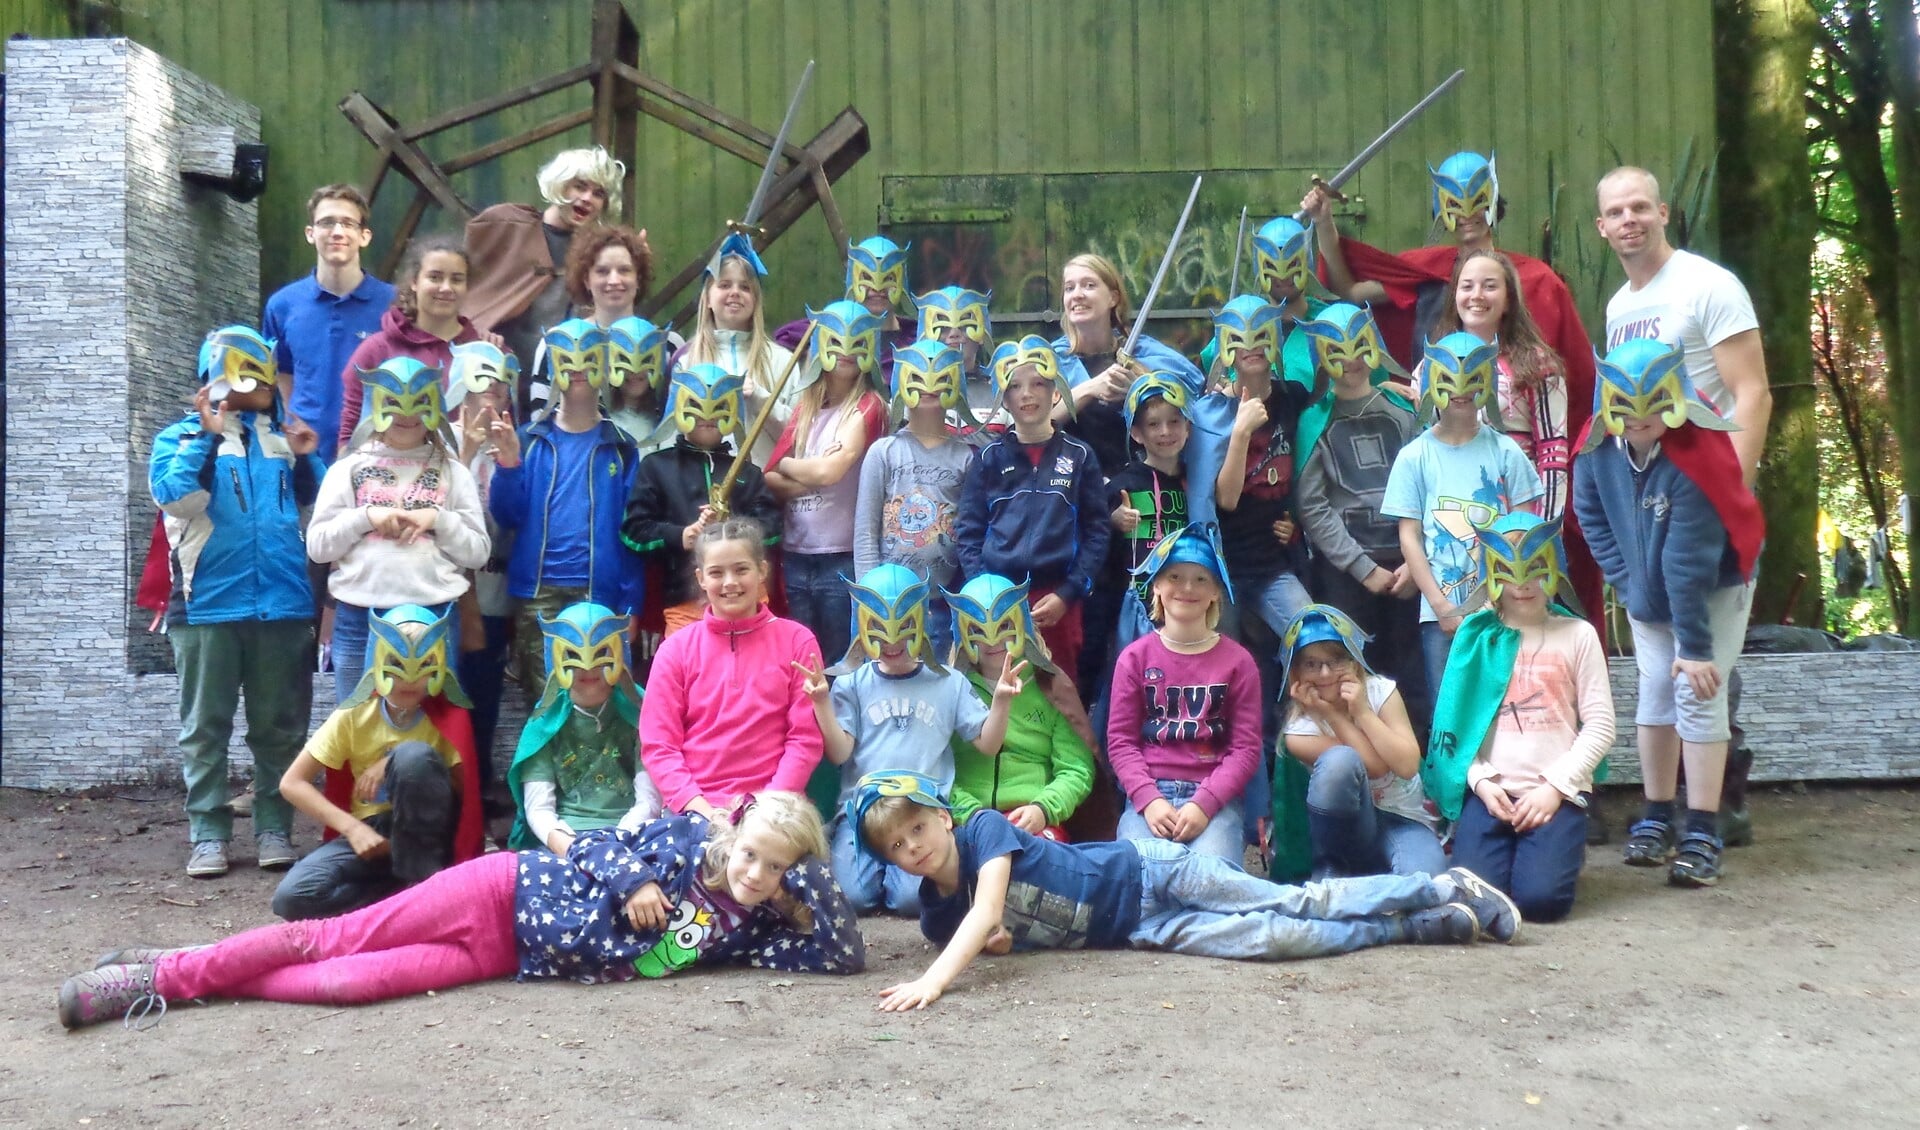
[{"x1": 1308, "y1": 746, "x2": 1446, "y2": 875}]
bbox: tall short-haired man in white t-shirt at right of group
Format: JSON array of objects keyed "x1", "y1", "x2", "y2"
[{"x1": 1594, "y1": 165, "x2": 1774, "y2": 844}]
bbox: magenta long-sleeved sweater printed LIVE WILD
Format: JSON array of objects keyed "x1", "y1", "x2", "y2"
[{"x1": 1106, "y1": 633, "x2": 1260, "y2": 819}]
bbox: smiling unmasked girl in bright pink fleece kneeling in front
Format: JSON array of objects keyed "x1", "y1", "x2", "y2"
[{"x1": 639, "y1": 518, "x2": 822, "y2": 819}]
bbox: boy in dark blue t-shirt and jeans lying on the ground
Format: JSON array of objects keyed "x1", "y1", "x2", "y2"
[{"x1": 849, "y1": 773, "x2": 1521, "y2": 1011}]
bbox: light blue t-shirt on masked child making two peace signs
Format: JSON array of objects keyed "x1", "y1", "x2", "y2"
[{"x1": 833, "y1": 662, "x2": 987, "y2": 810}]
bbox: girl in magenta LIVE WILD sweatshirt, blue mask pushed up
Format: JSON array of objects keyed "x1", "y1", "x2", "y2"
[{"x1": 1106, "y1": 524, "x2": 1260, "y2": 865}]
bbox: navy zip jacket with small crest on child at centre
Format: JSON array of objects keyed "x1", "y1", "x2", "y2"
[{"x1": 954, "y1": 432, "x2": 1112, "y2": 602}]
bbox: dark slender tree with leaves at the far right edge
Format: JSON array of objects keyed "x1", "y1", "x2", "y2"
[{"x1": 1807, "y1": 0, "x2": 1920, "y2": 633}]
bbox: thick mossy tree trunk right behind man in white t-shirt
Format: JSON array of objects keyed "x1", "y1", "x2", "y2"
[{"x1": 1713, "y1": 0, "x2": 1820, "y2": 625}]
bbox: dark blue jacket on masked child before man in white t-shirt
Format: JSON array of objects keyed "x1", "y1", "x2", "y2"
[{"x1": 1572, "y1": 437, "x2": 1745, "y2": 660}]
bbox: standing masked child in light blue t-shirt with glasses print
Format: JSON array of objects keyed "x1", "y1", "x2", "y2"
[{"x1": 1380, "y1": 334, "x2": 1546, "y2": 691}]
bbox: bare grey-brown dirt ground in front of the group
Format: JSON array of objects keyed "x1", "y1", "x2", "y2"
[{"x1": 0, "y1": 789, "x2": 1920, "y2": 1130}]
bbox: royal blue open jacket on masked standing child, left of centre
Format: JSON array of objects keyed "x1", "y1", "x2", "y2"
[{"x1": 488, "y1": 416, "x2": 641, "y2": 612}]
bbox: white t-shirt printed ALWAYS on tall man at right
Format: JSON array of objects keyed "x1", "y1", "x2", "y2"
[{"x1": 1607, "y1": 251, "x2": 1761, "y2": 416}]
